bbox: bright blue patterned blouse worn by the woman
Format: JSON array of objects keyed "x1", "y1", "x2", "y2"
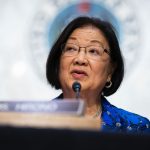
[{"x1": 56, "y1": 94, "x2": 150, "y2": 133}]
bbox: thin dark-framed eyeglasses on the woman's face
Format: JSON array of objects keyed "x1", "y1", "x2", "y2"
[{"x1": 62, "y1": 43, "x2": 110, "y2": 61}]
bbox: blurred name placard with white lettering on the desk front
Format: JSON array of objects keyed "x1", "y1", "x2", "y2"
[{"x1": 0, "y1": 99, "x2": 85, "y2": 115}]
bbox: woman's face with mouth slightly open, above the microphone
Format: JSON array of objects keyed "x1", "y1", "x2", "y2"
[{"x1": 59, "y1": 26, "x2": 112, "y2": 93}]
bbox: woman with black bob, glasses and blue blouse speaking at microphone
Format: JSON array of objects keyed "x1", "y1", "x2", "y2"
[{"x1": 46, "y1": 16, "x2": 150, "y2": 133}]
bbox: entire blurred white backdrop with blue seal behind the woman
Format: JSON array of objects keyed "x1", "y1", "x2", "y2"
[{"x1": 0, "y1": 0, "x2": 150, "y2": 119}]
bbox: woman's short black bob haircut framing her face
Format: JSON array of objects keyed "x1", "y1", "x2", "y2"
[{"x1": 46, "y1": 16, "x2": 124, "y2": 96}]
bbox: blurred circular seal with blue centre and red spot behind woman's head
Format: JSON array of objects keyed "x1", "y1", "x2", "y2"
[{"x1": 29, "y1": 0, "x2": 141, "y2": 78}]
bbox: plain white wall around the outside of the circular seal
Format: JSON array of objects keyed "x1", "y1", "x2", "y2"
[{"x1": 0, "y1": 0, "x2": 150, "y2": 118}]
